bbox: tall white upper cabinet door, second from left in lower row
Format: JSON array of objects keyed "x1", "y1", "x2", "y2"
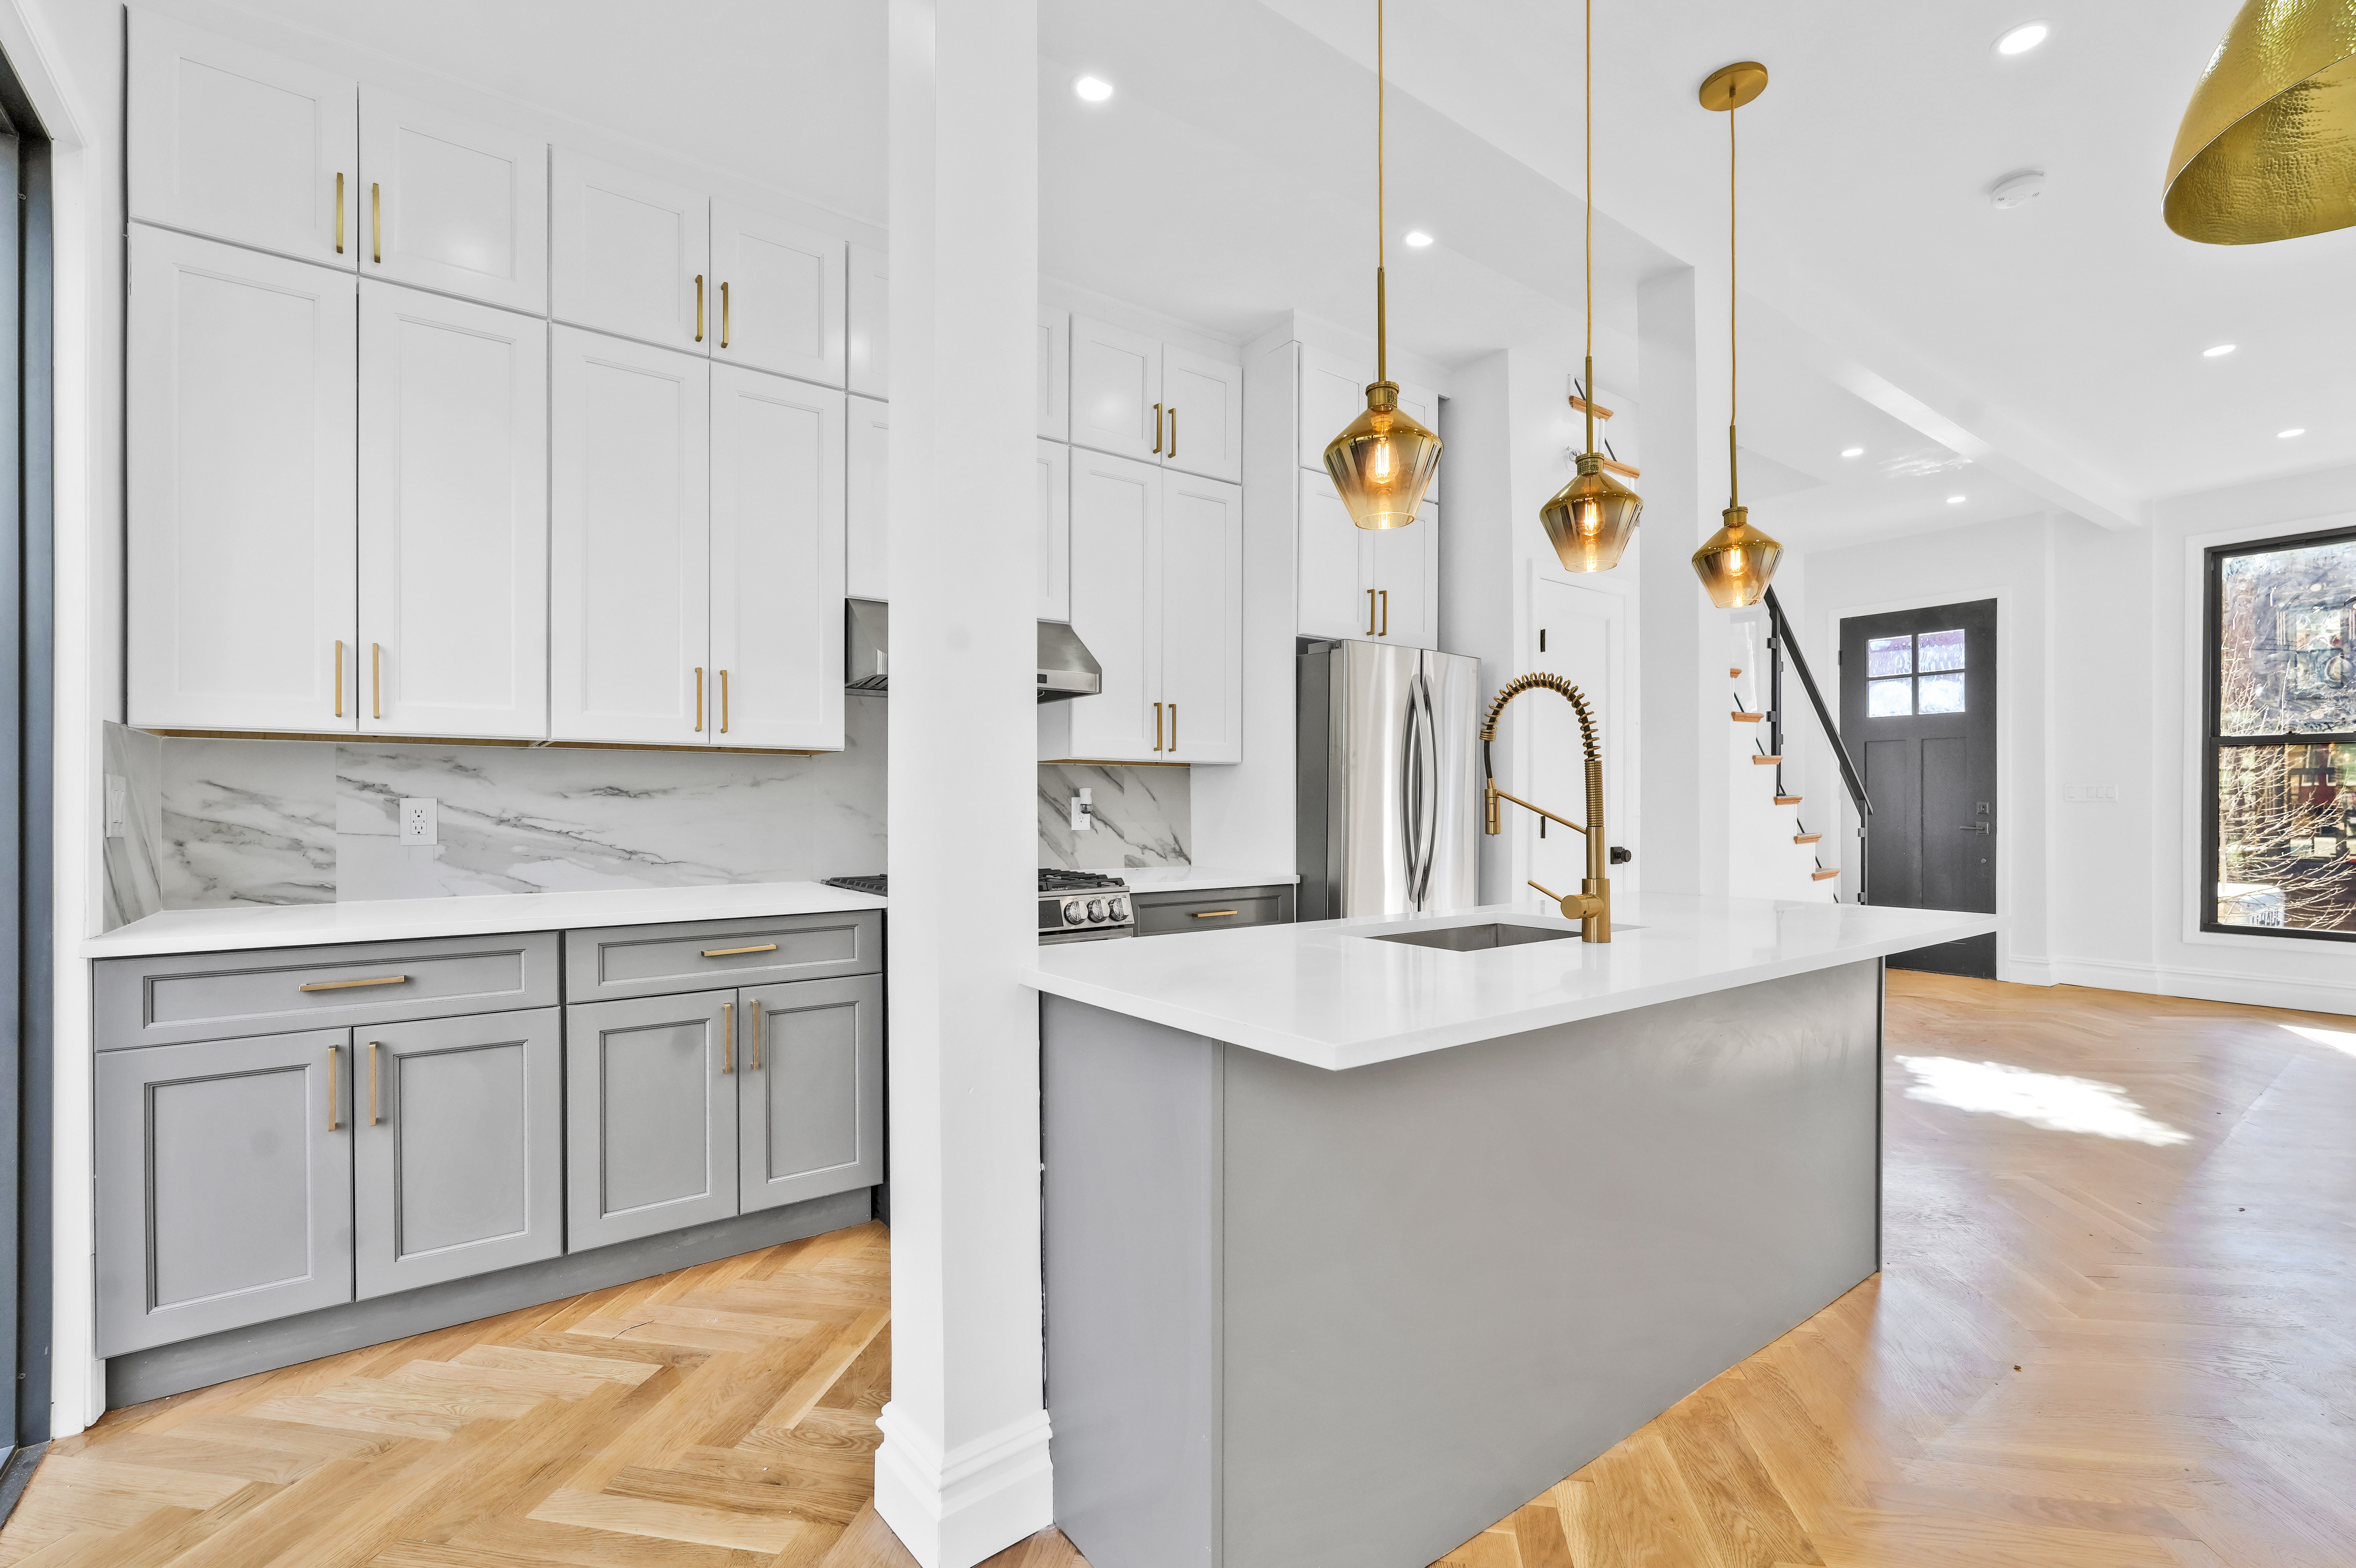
[{"x1": 358, "y1": 278, "x2": 549, "y2": 739}]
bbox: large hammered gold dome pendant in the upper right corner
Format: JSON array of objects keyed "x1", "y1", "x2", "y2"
[{"x1": 2160, "y1": 0, "x2": 2356, "y2": 245}]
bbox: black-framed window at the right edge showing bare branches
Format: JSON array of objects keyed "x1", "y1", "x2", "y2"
[{"x1": 2201, "y1": 530, "x2": 2356, "y2": 942}]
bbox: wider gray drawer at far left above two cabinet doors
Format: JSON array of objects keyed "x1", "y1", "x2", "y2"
[{"x1": 94, "y1": 932, "x2": 558, "y2": 1050}]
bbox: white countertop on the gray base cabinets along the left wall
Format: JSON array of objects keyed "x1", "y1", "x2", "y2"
[{"x1": 82, "y1": 883, "x2": 883, "y2": 958}]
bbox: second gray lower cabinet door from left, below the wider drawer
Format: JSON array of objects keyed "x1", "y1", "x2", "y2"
[{"x1": 351, "y1": 1008, "x2": 565, "y2": 1299}]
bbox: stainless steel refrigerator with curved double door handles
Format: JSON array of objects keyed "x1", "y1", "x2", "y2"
[{"x1": 1296, "y1": 643, "x2": 1482, "y2": 921}]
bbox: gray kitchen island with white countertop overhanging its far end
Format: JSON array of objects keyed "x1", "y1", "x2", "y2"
[{"x1": 1027, "y1": 895, "x2": 1998, "y2": 1568}]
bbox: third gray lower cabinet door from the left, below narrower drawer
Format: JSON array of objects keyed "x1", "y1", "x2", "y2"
[{"x1": 565, "y1": 991, "x2": 737, "y2": 1252}]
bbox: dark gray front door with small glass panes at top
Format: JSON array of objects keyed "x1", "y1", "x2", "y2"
[{"x1": 1840, "y1": 598, "x2": 1998, "y2": 979}]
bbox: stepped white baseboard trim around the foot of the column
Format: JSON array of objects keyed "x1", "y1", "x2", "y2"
[{"x1": 876, "y1": 1405, "x2": 1055, "y2": 1568}]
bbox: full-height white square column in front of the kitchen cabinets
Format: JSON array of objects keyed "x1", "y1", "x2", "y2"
[{"x1": 876, "y1": 0, "x2": 1053, "y2": 1568}]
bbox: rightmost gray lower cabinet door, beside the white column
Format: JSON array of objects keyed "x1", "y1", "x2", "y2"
[{"x1": 737, "y1": 975, "x2": 883, "y2": 1212}]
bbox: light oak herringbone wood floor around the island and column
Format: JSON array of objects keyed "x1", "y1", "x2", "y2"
[{"x1": 0, "y1": 972, "x2": 2356, "y2": 1568}]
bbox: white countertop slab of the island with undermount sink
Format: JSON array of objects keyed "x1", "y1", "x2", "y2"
[{"x1": 1022, "y1": 892, "x2": 2000, "y2": 1069}]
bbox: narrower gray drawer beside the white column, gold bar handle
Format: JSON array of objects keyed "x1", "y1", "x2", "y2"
[{"x1": 565, "y1": 909, "x2": 883, "y2": 1003}]
